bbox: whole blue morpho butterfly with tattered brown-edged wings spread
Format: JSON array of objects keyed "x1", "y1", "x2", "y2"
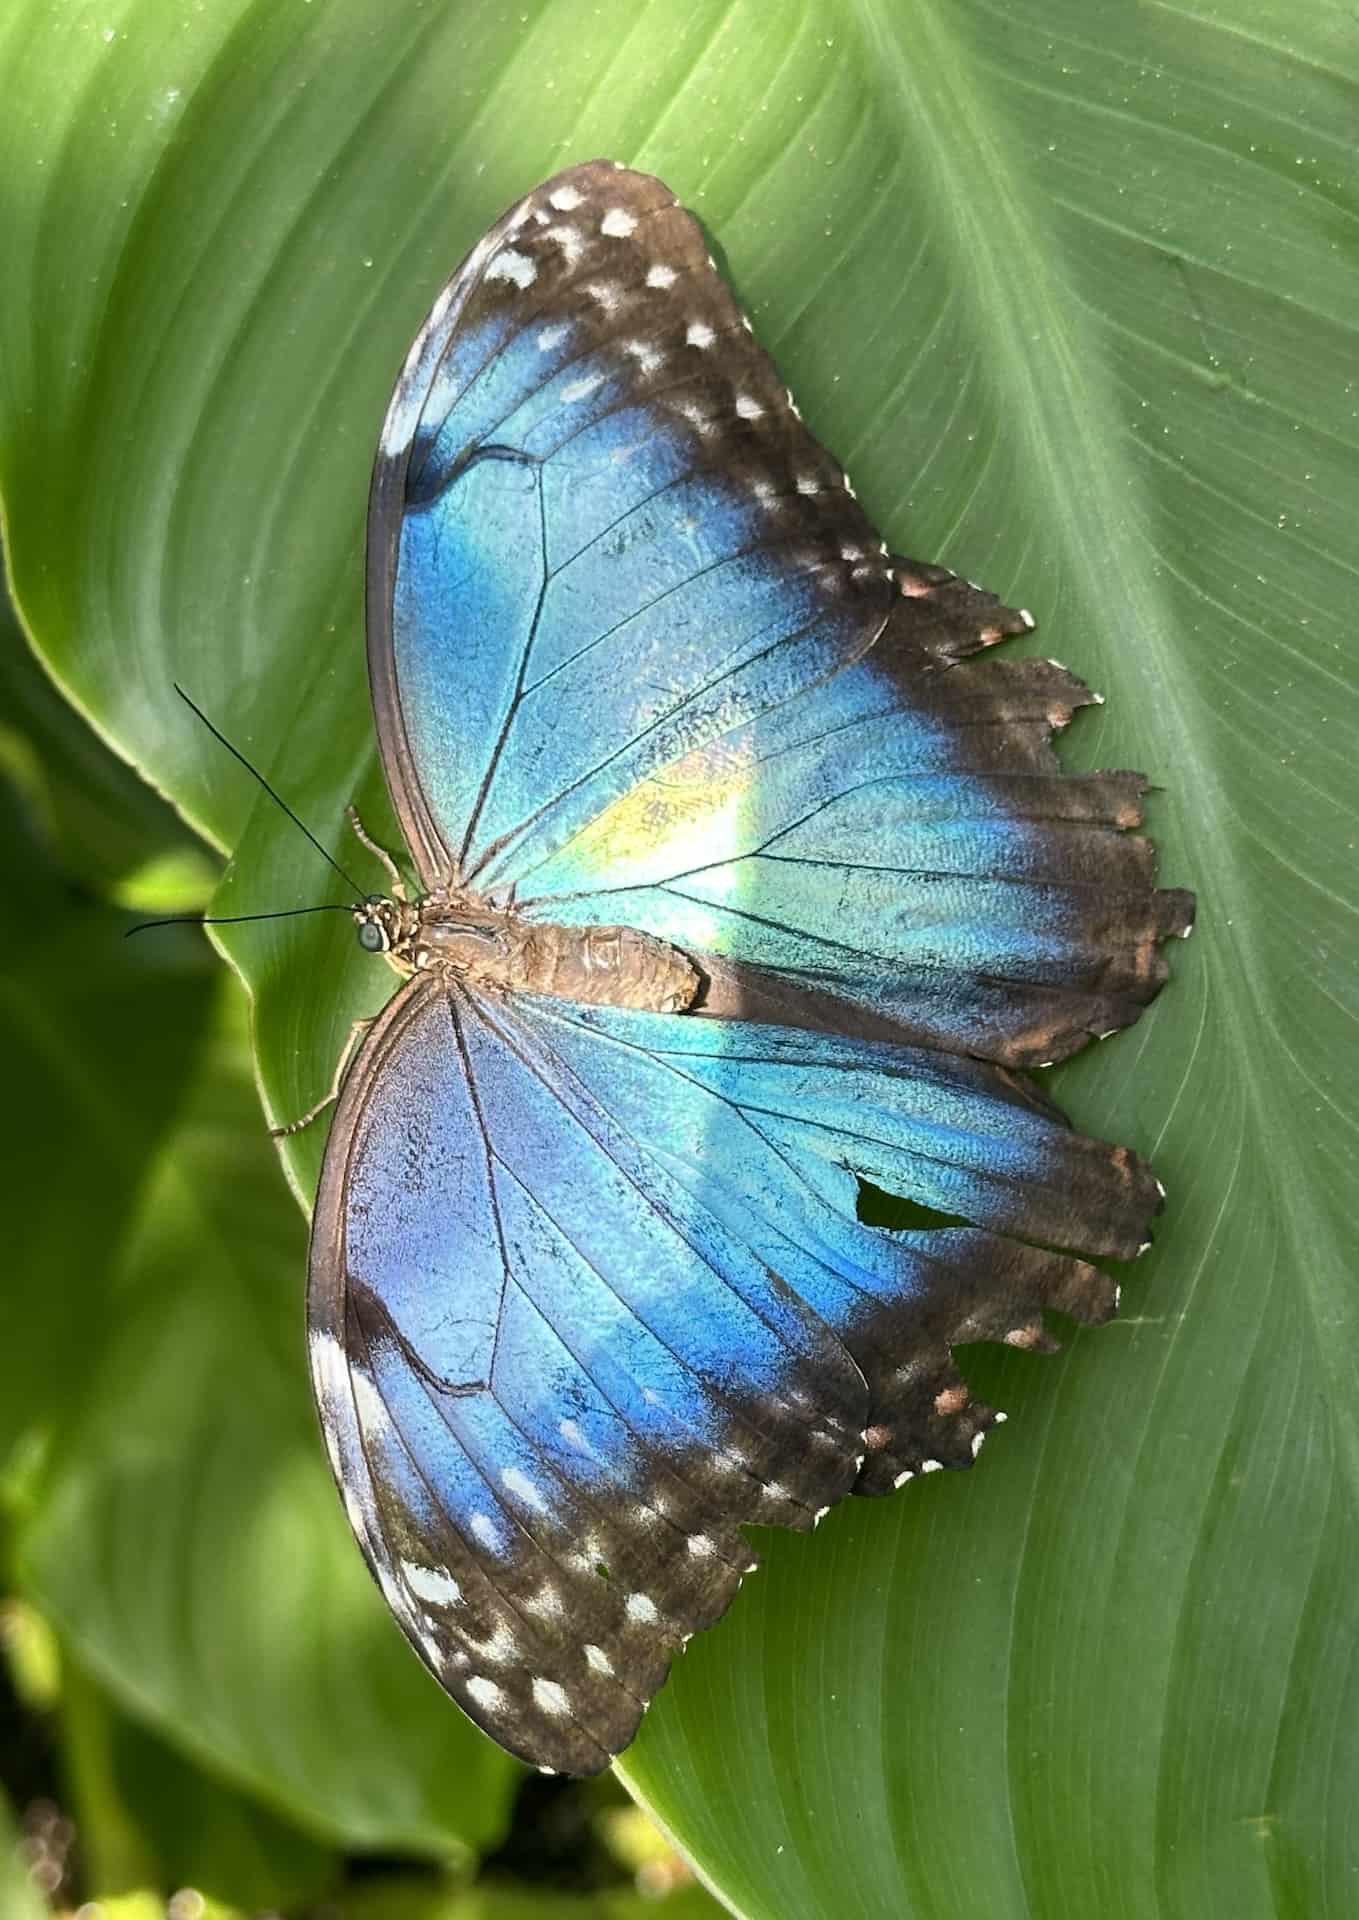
[{"x1": 297, "y1": 161, "x2": 1192, "y2": 1774}]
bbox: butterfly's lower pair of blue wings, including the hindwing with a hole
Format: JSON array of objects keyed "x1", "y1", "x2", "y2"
[{"x1": 309, "y1": 977, "x2": 1157, "y2": 1772}]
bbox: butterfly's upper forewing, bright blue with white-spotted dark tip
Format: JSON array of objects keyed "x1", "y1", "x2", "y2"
[{"x1": 369, "y1": 161, "x2": 894, "y2": 891}]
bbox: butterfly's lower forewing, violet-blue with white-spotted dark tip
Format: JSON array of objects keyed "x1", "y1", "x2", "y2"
[{"x1": 309, "y1": 981, "x2": 866, "y2": 1772}]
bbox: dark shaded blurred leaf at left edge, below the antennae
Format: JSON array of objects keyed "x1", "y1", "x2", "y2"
[{"x1": 0, "y1": 706, "x2": 219, "y2": 1463}]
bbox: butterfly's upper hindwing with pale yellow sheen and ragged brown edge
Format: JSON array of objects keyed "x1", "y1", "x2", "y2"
[{"x1": 525, "y1": 641, "x2": 1192, "y2": 1066}]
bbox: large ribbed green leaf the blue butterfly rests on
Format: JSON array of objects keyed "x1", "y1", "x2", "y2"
[{"x1": 0, "y1": 0, "x2": 1359, "y2": 1920}]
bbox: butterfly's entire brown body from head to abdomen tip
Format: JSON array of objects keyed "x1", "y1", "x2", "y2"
[{"x1": 353, "y1": 893, "x2": 701, "y2": 1014}]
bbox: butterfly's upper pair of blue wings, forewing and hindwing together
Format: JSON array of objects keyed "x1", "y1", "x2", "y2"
[{"x1": 369, "y1": 161, "x2": 1190, "y2": 1064}]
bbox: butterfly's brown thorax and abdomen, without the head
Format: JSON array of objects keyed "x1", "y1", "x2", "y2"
[{"x1": 418, "y1": 908, "x2": 699, "y2": 1014}]
